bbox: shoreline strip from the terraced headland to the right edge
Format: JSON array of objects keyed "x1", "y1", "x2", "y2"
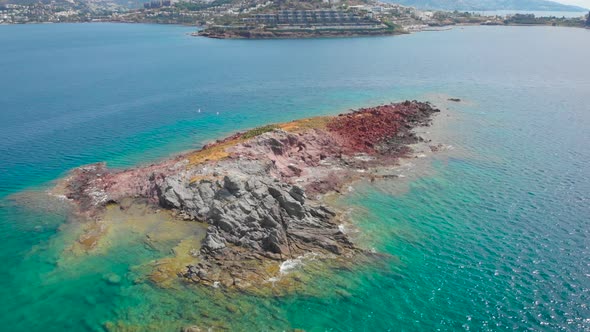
[{"x1": 193, "y1": 10, "x2": 590, "y2": 39}]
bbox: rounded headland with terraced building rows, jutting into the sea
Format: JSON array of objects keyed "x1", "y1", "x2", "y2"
[{"x1": 193, "y1": 0, "x2": 440, "y2": 38}]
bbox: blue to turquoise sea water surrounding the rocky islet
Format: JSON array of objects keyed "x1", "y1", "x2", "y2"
[{"x1": 0, "y1": 24, "x2": 590, "y2": 331}]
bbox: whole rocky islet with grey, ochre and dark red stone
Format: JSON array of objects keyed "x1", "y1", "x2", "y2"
[{"x1": 60, "y1": 101, "x2": 439, "y2": 289}]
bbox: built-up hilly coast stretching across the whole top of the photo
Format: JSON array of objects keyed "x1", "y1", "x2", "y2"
[{"x1": 0, "y1": 0, "x2": 586, "y2": 34}]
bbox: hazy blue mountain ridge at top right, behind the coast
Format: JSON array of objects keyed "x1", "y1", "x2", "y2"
[{"x1": 390, "y1": 0, "x2": 588, "y2": 12}]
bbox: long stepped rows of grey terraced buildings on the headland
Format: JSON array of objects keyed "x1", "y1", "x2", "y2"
[{"x1": 242, "y1": 10, "x2": 374, "y2": 25}]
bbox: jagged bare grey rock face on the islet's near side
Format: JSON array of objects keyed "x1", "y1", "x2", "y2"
[{"x1": 158, "y1": 174, "x2": 350, "y2": 274}]
